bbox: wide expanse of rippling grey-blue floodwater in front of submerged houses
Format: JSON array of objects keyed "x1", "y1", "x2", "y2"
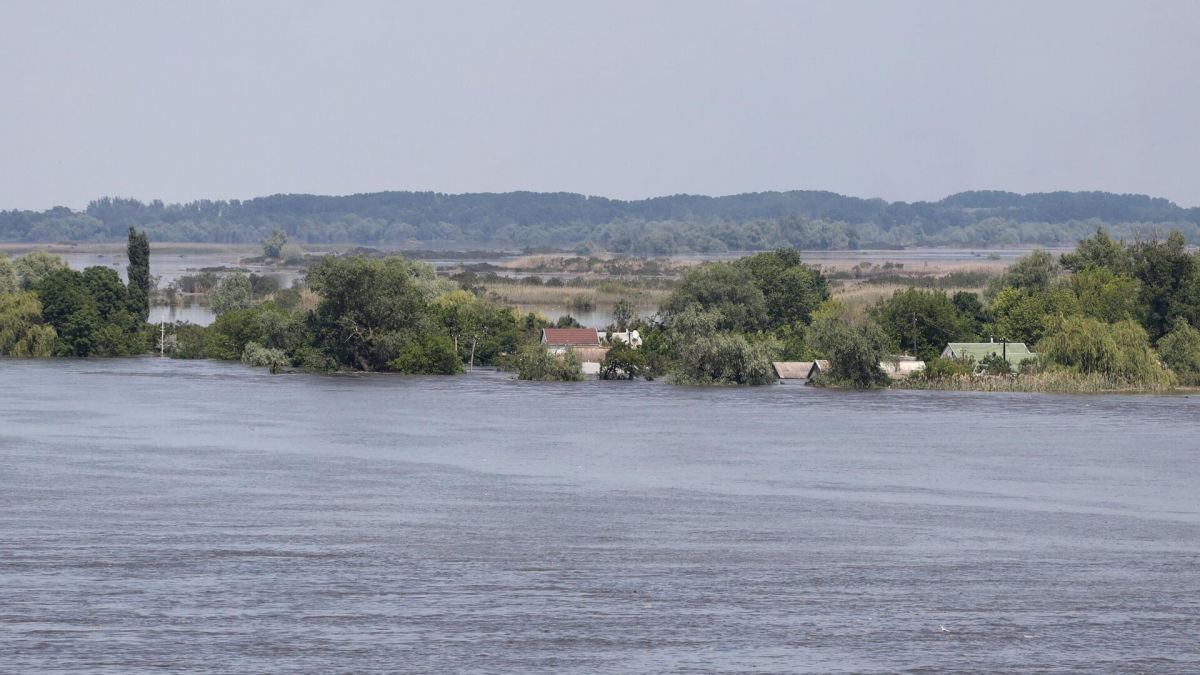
[{"x1": 0, "y1": 358, "x2": 1200, "y2": 673}]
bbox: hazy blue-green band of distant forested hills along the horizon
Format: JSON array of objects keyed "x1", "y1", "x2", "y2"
[{"x1": 0, "y1": 191, "x2": 1200, "y2": 256}]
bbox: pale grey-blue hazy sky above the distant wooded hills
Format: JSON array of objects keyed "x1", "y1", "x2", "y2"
[{"x1": 0, "y1": 0, "x2": 1200, "y2": 209}]
